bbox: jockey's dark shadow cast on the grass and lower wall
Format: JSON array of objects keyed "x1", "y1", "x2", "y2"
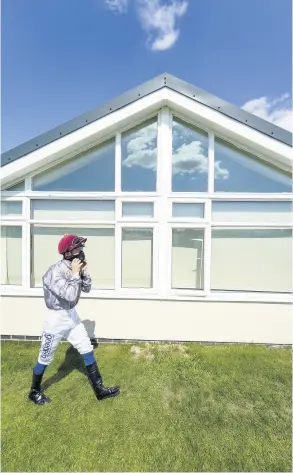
[{"x1": 42, "y1": 320, "x2": 98, "y2": 390}]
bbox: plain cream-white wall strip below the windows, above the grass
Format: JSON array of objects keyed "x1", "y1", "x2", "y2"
[{"x1": 1, "y1": 296, "x2": 292, "y2": 344}]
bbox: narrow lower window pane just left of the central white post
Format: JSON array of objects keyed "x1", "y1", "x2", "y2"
[{"x1": 121, "y1": 228, "x2": 153, "y2": 288}]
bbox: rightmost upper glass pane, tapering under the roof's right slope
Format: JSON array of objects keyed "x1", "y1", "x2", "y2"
[{"x1": 214, "y1": 138, "x2": 292, "y2": 192}]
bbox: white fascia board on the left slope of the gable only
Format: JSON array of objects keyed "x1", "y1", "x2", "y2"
[{"x1": 0, "y1": 89, "x2": 165, "y2": 186}]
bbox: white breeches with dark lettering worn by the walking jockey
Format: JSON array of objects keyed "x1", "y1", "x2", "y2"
[{"x1": 38, "y1": 309, "x2": 93, "y2": 365}]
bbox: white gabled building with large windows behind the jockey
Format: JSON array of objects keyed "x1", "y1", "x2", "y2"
[{"x1": 1, "y1": 74, "x2": 293, "y2": 344}]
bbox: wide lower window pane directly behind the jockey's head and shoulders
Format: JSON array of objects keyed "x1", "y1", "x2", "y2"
[{"x1": 31, "y1": 225, "x2": 115, "y2": 289}]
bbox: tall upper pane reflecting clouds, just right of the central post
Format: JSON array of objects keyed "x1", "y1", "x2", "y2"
[{"x1": 172, "y1": 118, "x2": 208, "y2": 192}]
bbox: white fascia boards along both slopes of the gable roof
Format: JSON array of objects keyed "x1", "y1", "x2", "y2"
[{"x1": 1, "y1": 88, "x2": 292, "y2": 186}]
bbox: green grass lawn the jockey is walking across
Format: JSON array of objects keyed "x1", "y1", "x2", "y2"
[{"x1": 1, "y1": 342, "x2": 292, "y2": 472}]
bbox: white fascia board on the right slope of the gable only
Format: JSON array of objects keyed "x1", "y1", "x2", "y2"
[{"x1": 166, "y1": 90, "x2": 292, "y2": 170}]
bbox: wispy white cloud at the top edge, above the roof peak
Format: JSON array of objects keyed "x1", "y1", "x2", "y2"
[{"x1": 105, "y1": 0, "x2": 188, "y2": 51}]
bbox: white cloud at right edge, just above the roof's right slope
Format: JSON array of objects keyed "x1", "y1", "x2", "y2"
[{"x1": 242, "y1": 94, "x2": 293, "y2": 132}]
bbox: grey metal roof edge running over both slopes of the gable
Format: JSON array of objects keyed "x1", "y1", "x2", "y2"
[{"x1": 1, "y1": 73, "x2": 292, "y2": 167}]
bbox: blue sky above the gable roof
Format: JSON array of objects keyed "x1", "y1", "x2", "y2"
[{"x1": 2, "y1": 0, "x2": 292, "y2": 151}]
